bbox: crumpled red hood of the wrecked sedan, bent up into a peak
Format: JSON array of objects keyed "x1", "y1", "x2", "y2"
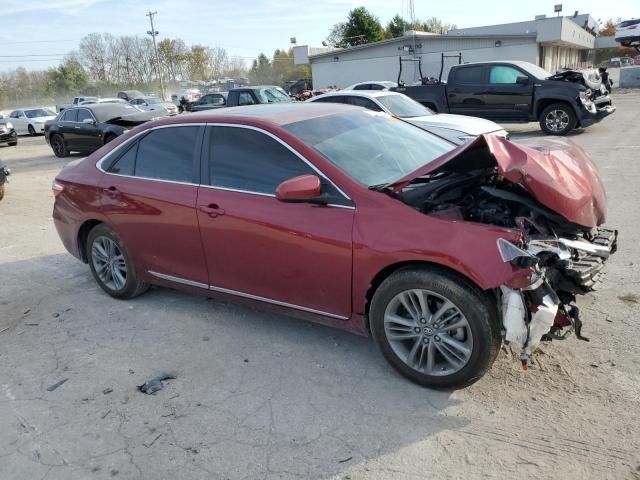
[{"x1": 390, "y1": 135, "x2": 607, "y2": 228}]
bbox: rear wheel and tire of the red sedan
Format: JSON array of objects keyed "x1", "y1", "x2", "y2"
[{"x1": 86, "y1": 224, "x2": 149, "y2": 299}]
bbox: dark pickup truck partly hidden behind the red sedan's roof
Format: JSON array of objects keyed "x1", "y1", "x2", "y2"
[{"x1": 185, "y1": 85, "x2": 292, "y2": 112}]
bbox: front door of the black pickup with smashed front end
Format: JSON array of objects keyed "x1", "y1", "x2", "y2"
[{"x1": 484, "y1": 65, "x2": 534, "y2": 121}]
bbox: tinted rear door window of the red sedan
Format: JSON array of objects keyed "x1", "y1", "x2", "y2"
[{"x1": 134, "y1": 126, "x2": 200, "y2": 183}]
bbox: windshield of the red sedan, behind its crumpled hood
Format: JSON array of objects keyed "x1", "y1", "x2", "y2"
[{"x1": 283, "y1": 109, "x2": 454, "y2": 187}]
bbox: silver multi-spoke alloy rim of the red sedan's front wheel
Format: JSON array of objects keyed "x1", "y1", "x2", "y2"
[{"x1": 384, "y1": 289, "x2": 473, "y2": 376}]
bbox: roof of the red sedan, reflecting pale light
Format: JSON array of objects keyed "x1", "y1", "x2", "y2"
[{"x1": 168, "y1": 102, "x2": 359, "y2": 126}]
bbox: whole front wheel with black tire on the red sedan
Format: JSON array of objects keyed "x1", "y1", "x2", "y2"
[{"x1": 370, "y1": 268, "x2": 501, "y2": 388}]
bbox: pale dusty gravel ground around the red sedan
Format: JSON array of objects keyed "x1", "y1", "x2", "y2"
[{"x1": 0, "y1": 92, "x2": 640, "y2": 480}]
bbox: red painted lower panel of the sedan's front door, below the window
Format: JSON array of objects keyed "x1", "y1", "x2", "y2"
[{"x1": 198, "y1": 187, "x2": 354, "y2": 317}]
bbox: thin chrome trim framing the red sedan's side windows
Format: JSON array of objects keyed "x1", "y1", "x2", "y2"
[{"x1": 96, "y1": 122, "x2": 355, "y2": 205}]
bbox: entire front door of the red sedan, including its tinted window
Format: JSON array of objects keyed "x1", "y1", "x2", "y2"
[{"x1": 197, "y1": 126, "x2": 355, "y2": 319}]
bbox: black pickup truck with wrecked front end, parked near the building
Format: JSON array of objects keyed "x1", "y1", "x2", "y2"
[{"x1": 395, "y1": 62, "x2": 615, "y2": 135}]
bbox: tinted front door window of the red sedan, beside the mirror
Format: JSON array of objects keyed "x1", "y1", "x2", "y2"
[{"x1": 209, "y1": 127, "x2": 316, "y2": 194}]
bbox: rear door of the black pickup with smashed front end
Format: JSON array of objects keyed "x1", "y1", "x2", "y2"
[{"x1": 446, "y1": 65, "x2": 487, "y2": 117}]
